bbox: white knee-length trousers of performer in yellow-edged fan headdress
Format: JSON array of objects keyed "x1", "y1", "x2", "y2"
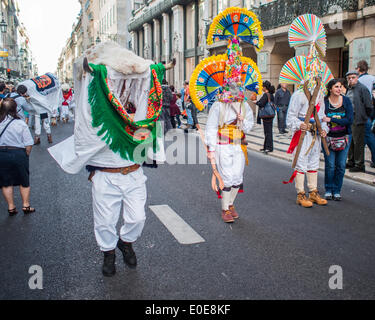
[{"x1": 215, "y1": 144, "x2": 245, "y2": 188}]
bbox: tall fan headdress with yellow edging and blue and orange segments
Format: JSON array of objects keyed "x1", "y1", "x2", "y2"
[{"x1": 189, "y1": 7, "x2": 263, "y2": 110}]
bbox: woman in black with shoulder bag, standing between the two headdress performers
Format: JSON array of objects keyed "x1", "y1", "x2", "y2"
[{"x1": 256, "y1": 81, "x2": 276, "y2": 154}]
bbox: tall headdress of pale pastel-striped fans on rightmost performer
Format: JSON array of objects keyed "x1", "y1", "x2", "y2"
[{"x1": 279, "y1": 14, "x2": 333, "y2": 92}]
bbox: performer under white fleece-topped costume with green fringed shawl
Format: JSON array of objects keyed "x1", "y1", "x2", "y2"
[{"x1": 49, "y1": 43, "x2": 170, "y2": 276}]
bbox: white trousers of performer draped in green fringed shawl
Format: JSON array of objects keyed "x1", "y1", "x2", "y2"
[{"x1": 92, "y1": 168, "x2": 147, "y2": 251}]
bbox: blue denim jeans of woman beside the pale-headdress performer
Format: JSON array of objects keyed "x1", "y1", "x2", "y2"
[{"x1": 322, "y1": 135, "x2": 352, "y2": 194}]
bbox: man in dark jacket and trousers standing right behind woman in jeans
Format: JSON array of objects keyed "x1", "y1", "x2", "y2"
[{"x1": 346, "y1": 71, "x2": 373, "y2": 172}]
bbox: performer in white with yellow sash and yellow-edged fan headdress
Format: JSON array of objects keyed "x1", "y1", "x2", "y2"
[{"x1": 189, "y1": 8, "x2": 263, "y2": 223}]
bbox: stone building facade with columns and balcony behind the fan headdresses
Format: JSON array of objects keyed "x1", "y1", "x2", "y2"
[{"x1": 129, "y1": 0, "x2": 375, "y2": 87}]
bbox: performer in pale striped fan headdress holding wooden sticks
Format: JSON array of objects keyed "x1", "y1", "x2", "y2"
[{"x1": 279, "y1": 14, "x2": 333, "y2": 208}]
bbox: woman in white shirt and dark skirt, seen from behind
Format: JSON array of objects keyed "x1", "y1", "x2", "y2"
[{"x1": 0, "y1": 98, "x2": 35, "y2": 216}]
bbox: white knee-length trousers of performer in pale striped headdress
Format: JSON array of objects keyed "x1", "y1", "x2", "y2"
[{"x1": 294, "y1": 132, "x2": 321, "y2": 172}]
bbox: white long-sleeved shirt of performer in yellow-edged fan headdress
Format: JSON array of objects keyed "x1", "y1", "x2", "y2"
[{"x1": 205, "y1": 101, "x2": 254, "y2": 151}]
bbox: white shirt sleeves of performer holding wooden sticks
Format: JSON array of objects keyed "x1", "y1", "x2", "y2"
[{"x1": 286, "y1": 90, "x2": 329, "y2": 133}]
